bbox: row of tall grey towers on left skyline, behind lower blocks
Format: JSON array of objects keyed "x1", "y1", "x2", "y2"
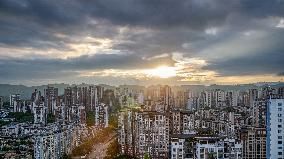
[{"x1": 10, "y1": 86, "x2": 109, "y2": 125}]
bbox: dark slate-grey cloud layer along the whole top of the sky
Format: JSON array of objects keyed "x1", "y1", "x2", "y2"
[{"x1": 0, "y1": 0, "x2": 284, "y2": 47}]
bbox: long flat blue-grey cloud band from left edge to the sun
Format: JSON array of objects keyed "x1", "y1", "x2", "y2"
[{"x1": 0, "y1": 54, "x2": 175, "y2": 79}]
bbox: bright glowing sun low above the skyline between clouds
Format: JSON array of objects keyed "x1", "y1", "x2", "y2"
[{"x1": 146, "y1": 66, "x2": 176, "y2": 78}]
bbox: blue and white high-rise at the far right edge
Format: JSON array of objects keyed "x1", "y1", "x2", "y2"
[{"x1": 266, "y1": 99, "x2": 284, "y2": 159}]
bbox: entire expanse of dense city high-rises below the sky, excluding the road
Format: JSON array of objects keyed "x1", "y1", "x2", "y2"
[{"x1": 0, "y1": 85, "x2": 284, "y2": 159}]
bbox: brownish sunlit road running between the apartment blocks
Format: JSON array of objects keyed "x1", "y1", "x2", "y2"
[{"x1": 86, "y1": 134, "x2": 116, "y2": 159}]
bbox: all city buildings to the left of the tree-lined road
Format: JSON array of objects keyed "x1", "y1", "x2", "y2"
[{"x1": 0, "y1": 86, "x2": 111, "y2": 159}]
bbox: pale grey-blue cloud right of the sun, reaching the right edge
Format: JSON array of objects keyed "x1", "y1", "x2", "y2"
[{"x1": 198, "y1": 29, "x2": 284, "y2": 76}]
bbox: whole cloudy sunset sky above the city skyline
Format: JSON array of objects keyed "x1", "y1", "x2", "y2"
[{"x1": 0, "y1": 0, "x2": 284, "y2": 85}]
